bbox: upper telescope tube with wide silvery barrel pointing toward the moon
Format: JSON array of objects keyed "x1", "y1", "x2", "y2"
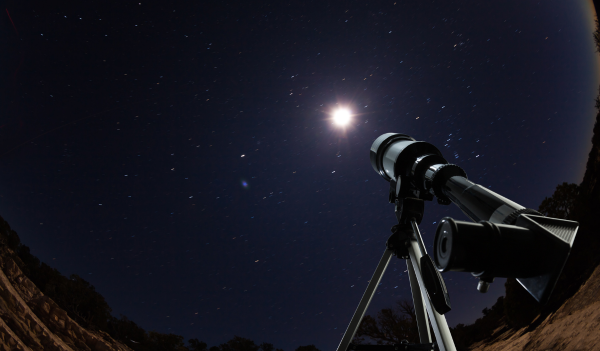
[{"x1": 371, "y1": 133, "x2": 541, "y2": 225}]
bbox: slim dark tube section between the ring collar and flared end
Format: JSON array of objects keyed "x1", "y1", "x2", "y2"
[{"x1": 442, "y1": 176, "x2": 525, "y2": 223}]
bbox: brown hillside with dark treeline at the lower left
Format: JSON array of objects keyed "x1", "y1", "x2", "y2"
[{"x1": 0, "y1": 217, "x2": 319, "y2": 351}]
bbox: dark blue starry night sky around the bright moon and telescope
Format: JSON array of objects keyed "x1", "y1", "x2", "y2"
[{"x1": 0, "y1": 0, "x2": 599, "y2": 351}]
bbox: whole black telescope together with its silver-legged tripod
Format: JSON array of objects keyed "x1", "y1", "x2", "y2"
[{"x1": 337, "y1": 133, "x2": 579, "y2": 351}]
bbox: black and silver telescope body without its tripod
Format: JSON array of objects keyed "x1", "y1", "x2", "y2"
[{"x1": 370, "y1": 133, "x2": 578, "y2": 303}]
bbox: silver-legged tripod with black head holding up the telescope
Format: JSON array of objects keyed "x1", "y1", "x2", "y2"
[{"x1": 337, "y1": 198, "x2": 456, "y2": 351}]
